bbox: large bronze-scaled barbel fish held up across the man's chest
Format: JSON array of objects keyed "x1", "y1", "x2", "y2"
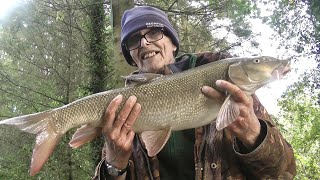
[{"x1": 0, "y1": 56, "x2": 290, "y2": 175}]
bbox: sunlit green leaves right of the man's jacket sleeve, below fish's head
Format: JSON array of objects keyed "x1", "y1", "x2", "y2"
[{"x1": 279, "y1": 70, "x2": 320, "y2": 179}]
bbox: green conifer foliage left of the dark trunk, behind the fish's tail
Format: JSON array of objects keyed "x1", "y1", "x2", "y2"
[{"x1": 0, "y1": 0, "x2": 112, "y2": 179}]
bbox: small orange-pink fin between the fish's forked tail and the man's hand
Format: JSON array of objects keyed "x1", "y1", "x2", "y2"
[{"x1": 69, "y1": 124, "x2": 101, "y2": 148}]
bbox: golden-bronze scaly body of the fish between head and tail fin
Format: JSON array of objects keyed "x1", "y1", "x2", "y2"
[{"x1": 49, "y1": 61, "x2": 229, "y2": 133}]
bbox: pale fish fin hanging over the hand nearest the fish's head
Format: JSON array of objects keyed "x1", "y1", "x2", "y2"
[{"x1": 216, "y1": 95, "x2": 240, "y2": 131}]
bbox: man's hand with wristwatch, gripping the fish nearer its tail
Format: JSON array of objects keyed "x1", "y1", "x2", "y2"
[{"x1": 102, "y1": 95, "x2": 141, "y2": 169}]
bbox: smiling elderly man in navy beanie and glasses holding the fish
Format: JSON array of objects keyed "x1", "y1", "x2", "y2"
[{"x1": 95, "y1": 6, "x2": 296, "y2": 179}]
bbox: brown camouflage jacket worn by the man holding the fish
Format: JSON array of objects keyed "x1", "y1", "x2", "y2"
[{"x1": 93, "y1": 52, "x2": 296, "y2": 180}]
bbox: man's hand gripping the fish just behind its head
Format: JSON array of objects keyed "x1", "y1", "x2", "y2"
[{"x1": 202, "y1": 80, "x2": 261, "y2": 149}]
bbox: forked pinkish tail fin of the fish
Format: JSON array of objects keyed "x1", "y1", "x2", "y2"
[{"x1": 0, "y1": 111, "x2": 62, "y2": 176}]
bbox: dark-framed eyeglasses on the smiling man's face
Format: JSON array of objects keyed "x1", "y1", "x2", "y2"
[{"x1": 125, "y1": 29, "x2": 164, "y2": 51}]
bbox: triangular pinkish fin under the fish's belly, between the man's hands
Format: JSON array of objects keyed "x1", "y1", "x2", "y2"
[{"x1": 141, "y1": 128, "x2": 171, "y2": 157}]
